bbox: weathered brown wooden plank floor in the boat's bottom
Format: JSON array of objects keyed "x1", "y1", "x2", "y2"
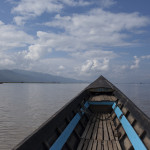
[{"x1": 77, "y1": 114, "x2": 121, "y2": 150}]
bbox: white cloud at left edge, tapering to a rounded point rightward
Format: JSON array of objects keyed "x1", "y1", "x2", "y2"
[{"x1": 0, "y1": 21, "x2": 34, "y2": 50}]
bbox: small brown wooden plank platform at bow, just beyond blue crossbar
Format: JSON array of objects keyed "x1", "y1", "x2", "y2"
[{"x1": 91, "y1": 95, "x2": 117, "y2": 101}]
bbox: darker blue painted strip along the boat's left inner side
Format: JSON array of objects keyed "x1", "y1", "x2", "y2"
[{"x1": 49, "y1": 102, "x2": 89, "y2": 150}]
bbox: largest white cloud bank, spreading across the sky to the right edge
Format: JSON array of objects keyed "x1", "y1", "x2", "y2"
[{"x1": 22, "y1": 9, "x2": 149, "y2": 60}]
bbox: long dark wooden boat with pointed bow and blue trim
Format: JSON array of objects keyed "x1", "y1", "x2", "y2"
[{"x1": 14, "y1": 76, "x2": 150, "y2": 150}]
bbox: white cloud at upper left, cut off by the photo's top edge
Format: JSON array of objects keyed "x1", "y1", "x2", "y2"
[{"x1": 12, "y1": 0, "x2": 90, "y2": 25}]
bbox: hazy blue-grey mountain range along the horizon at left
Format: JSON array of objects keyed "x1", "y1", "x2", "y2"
[{"x1": 0, "y1": 69, "x2": 83, "y2": 83}]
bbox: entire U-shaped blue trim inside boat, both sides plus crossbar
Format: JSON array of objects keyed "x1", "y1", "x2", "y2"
[{"x1": 49, "y1": 101, "x2": 147, "y2": 150}]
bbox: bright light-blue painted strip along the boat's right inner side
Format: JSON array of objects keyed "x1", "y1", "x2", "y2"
[{"x1": 112, "y1": 103, "x2": 147, "y2": 150}]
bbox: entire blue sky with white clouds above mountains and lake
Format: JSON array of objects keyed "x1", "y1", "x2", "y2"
[{"x1": 0, "y1": 0, "x2": 150, "y2": 83}]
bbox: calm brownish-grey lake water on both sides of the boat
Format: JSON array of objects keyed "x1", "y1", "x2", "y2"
[{"x1": 0, "y1": 83, "x2": 150, "y2": 150}]
